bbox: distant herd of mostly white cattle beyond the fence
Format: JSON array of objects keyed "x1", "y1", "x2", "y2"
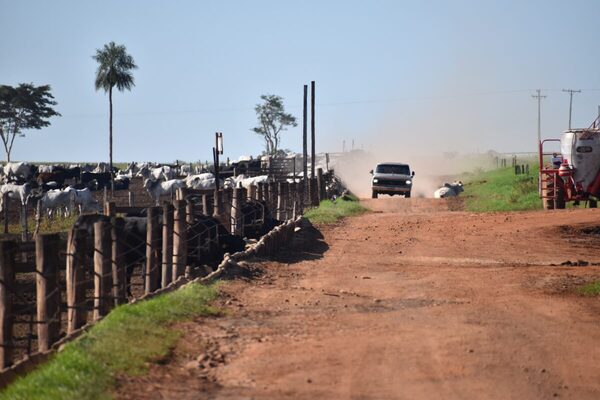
[{"x1": 0, "y1": 158, "x2": 341, "y2": 225}]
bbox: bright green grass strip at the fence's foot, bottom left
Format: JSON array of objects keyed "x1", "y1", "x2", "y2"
[{"x1": 0, "y1": 284, "x2": 217, "y2": 400}]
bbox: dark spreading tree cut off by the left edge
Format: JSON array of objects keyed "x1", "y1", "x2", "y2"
[{"x1": 0, "y1": 83, "x2": 60, "y2": 162}]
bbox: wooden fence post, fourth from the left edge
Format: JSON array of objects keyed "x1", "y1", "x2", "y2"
[{"x1": 94, "y1": 221, "x2": 112, "y2": 320}]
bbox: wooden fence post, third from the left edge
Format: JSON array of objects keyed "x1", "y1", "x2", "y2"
[{"x1": 66, "y1": 229, "x2": 87, "y2": 333}]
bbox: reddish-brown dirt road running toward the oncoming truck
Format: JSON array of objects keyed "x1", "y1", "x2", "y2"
[{"x1": 117, "y1": 198, "x2": 600, "y2": 399}]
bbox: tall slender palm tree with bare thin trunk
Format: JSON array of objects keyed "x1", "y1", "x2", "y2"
[{"x1": 92, "y1": 42, "x2": 137, "y2": 175}]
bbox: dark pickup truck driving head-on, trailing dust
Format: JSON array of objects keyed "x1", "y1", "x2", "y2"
[{"x1": 371, "y1": 163, "x2": 415, "y2": 199}]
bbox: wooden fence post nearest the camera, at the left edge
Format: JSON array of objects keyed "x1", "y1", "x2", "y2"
[{"x1": 0, "y1": 239, "x2": 16, "y2": 368}]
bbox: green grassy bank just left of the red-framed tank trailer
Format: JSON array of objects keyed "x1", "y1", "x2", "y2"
[{"x1": 464, "y1": 165, "x2": 542, "y2": 211}]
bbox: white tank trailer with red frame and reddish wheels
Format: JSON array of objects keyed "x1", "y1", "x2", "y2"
[{"x1": 539, "y1": 117, "x2": 600, "y2": 209}]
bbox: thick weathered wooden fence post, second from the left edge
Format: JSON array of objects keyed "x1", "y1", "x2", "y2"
[{"x1": 35, "y1": 233, "x2": 60, "y2": 351}]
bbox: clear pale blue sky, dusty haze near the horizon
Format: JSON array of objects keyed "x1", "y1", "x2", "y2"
[{"x1": 0, "y1": 0, "x2": 600, "y2": 161}]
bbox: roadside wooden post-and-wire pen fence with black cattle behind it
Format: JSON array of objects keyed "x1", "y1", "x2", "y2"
[{"x1": 0, "y1": 173, "x2": 326, "y2": 383}]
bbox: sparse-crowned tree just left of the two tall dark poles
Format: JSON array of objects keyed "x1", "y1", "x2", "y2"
[{"x1": 252, "y1": 94, "x2": 298, "y2": 155}]
